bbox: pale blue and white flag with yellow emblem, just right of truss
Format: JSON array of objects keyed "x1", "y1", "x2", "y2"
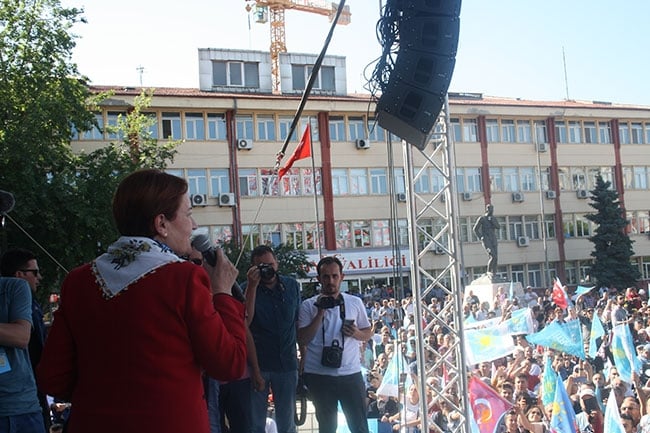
[{"x1": 465, "y1": 327, "x2": 515, "y2": 365}]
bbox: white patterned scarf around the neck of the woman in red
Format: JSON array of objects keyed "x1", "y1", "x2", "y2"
[{"x1": 91, "y1": 236, "x2": 183, "y2": 299}]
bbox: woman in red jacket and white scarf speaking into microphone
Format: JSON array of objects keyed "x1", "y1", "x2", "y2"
[{"x1": 37, "y1": 170, "x2": 246, "y2": 433}]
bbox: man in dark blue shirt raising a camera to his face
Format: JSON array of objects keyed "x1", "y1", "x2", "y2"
[{"x1": 243, "y1": 245, "x2": 300, "y2": 433}]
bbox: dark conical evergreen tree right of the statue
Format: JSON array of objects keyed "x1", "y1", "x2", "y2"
[{"x1": 586, "y1": 175, "x2": 641, "y2": 289}]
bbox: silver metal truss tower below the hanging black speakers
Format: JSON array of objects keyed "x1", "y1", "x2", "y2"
[{"x1": 402, "y1": 100, "x2": 472, "y2": 432}]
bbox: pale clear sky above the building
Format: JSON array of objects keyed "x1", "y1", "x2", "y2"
[{"x1": 62, "y1": 0, "x2": 650, "y2": 106}]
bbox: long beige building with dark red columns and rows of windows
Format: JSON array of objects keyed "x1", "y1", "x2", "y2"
[{"x1": 72, "y1": 49, "x2": 650, "y2": 292}]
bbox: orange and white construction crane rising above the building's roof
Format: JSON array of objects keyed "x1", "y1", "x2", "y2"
[{"x1": 246, "y1": 0, "x2": 350, "y2": 95}]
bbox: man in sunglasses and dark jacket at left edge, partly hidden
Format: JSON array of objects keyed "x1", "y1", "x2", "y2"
[{"x1": 0, "y1": 248, "x2": 50, "y2": 431}]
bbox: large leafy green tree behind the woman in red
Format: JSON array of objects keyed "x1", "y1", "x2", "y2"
[{"x1": 0, "y1": 0, "x2": 177, "y2": 299}]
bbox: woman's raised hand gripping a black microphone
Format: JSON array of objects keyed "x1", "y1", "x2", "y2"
[{"x1": 192, "y1": 234, "x2": 244, "y2": 302}]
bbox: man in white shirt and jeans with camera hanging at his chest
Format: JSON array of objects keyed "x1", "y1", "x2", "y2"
[{"x1": 298, "y1": 257, "x2": 372, "y2": 433}]
